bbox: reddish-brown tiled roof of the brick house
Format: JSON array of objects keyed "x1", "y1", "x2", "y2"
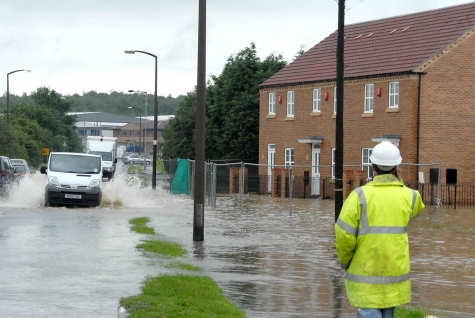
[{"x1": 260, "y1": 2, "x2": 475, "y2": 88}]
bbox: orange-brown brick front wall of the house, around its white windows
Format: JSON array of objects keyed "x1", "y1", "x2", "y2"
[{"x1": 259, "y1": 75, "x2": 418, "y2": 178}]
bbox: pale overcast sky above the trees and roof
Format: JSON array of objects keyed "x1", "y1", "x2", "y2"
[{"x1": 0, "y1": 0, "x2": 469, "y2": 97}]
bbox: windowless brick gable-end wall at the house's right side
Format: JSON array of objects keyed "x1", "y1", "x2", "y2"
[{"x1": 420, "y1": 30, "x2": 475, "y2": 183}]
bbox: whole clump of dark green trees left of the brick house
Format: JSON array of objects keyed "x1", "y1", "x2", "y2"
[{"x1": 162, "y1": 43, "x2": 286, "y2": 162}]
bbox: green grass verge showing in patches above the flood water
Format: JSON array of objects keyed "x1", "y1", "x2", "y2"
[{"x1": 120, "y1": 217, "x2": 246, "y2": 318}]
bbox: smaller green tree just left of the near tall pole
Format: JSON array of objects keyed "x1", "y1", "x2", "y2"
[{"x1": 162, "y1": 90, "x2": 196, "y2": 159}]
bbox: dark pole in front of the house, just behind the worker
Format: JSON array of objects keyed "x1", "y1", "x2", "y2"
[{"x1": 335, "y1": 0, "x2": 345, "y2": 222}]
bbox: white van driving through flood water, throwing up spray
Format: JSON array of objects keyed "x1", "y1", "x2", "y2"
[{"x1": 41, "y1": 152, "x2": 102, "y2": 206}]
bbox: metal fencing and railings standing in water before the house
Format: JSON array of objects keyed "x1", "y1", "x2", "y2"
[{"x1": 163, "y1": 159, "x2": 475, "y2": 213}]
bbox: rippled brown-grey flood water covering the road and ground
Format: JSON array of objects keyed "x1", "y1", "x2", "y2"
[{"x1": 0, "y1": 163, "x2": 475, "y2": 317}]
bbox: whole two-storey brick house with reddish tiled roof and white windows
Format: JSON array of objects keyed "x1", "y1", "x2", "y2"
[{"x1": 259, "y1": 3, "x2": 475, "y2": 195}]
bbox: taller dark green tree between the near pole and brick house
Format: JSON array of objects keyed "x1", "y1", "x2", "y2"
[{"x1": 206, "y1": 43, "x2": 286, "y2": 162}]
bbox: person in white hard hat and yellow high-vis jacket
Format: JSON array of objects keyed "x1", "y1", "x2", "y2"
[{"x1": 335, "y1": 141, "x2": 425, "y2": 318}]
